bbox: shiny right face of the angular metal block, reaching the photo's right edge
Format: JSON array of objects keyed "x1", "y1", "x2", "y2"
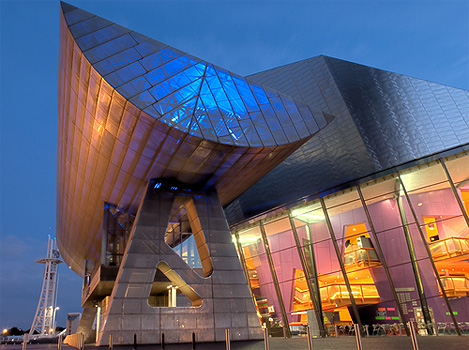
[{"x1": 326, "y1": 57, "x2": 469, "y2": 170}]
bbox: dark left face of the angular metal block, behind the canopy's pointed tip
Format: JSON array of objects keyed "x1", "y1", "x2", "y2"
[{"x1": 226, "y1": 56, "x2": 375, "y2": 222}]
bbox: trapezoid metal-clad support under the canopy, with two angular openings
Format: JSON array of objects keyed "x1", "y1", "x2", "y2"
[{"x1": 96, "y1": 180, "x2": 262, "y2": 345}]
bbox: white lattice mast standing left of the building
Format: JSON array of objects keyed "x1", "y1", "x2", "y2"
[{"x1": 29, "y1": 235, "x2": 63, "y2": 335}]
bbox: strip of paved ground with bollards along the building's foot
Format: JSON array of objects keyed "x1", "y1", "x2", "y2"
[{"x1": 1, "y1": 335, "x2": 469, "y2": 350}]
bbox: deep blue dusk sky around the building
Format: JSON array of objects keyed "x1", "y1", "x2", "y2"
[{"x1": 0, "y1": 0, "x2": 469, "y2": 329}]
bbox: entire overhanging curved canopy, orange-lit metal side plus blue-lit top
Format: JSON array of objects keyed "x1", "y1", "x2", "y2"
[{"x1": 57, "y1": 6, "x2": 326, "y2": 274}]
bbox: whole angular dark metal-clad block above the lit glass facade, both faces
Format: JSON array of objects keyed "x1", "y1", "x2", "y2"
[{"x1": 226, "y1": 56, "x2": 469, "y2": 222}]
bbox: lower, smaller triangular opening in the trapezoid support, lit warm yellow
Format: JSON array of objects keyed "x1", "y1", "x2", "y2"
[{"x1": 148, "y1": 262, "x2": 202, "y2": 307}]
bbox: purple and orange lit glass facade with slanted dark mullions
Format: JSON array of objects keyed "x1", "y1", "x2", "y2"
[{"x1": 233, "y1": 152, "x2": 469, "y2": 335}]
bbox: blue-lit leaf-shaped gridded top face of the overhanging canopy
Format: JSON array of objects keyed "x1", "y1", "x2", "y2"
[{"x1": 62, "y1": 3, "x2": 319, "y2": 147}]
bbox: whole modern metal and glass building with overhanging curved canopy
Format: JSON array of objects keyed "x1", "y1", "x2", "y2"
[{"x1": 57, "y1": 3, "x2": 469, "y2": 345}]
